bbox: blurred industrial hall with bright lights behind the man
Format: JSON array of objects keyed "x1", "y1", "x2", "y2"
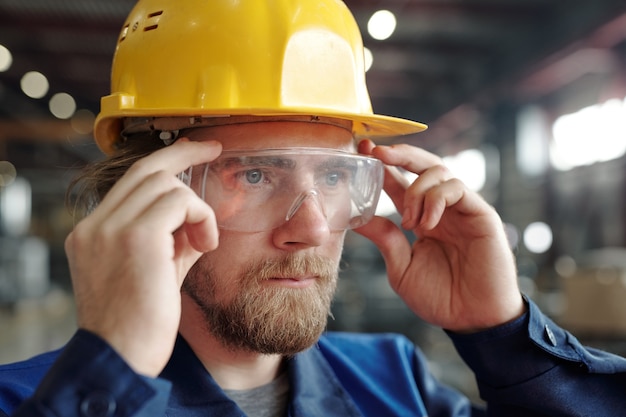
[{"x1": 0, "y1": 0, "x2": 626, "y2": 404}]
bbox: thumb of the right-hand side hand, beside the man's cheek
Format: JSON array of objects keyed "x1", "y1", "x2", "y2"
[{"x1": 354, "y1": 216, "x2": 411, "y2": 280}]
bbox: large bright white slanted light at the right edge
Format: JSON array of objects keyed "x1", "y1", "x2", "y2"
[{"x1": 550, "y1": 99, "x2": 626, "y2": 171}]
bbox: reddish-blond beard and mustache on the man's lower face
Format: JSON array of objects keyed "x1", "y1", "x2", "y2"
[{"x1": 183, "y1": 254, "x2": 338, "y2": 355}]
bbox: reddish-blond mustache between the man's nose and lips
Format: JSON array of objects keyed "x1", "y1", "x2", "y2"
[{"x1": 243, "y1": 255, "x2": 339, "y2": 282}]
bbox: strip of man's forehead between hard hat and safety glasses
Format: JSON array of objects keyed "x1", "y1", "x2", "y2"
[{"x1": 185, "y1": 121, "x2": 355, "y2": 151}]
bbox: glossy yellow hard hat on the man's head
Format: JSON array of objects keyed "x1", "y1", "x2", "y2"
[{"x1": 94, "y1": 0, "x2": 426, "y2": 154}]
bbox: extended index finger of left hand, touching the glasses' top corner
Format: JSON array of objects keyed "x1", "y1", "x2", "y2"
[{"x1": 93, "y1": 138, "x2": 222, "y2": 216}]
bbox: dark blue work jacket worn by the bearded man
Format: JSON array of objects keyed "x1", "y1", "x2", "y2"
[{"x1": 0, "y1": 302, "x2": 626, "y2": 417}]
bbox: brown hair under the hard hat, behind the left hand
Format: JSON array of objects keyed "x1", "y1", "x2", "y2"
[{"x1": 65, "y1": 132, "x2": 165, "y2": 218}]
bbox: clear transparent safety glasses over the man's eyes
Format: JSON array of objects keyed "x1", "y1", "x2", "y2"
[{"x1": 179, "y1": 148, "x2": 384, "y2": 232}]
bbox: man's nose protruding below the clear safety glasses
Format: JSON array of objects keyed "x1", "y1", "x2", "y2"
[{"x1": 273, "y1": 190, "x2": 331, "y2": 250}]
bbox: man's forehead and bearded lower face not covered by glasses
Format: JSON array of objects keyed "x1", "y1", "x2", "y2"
[{"x1": 183, "y1": 122, "x2": 354, "y2": 355}]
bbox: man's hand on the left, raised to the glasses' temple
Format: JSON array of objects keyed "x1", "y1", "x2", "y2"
[{"x1": 65, "y1": 139, "x2": 221, "y2": 376}]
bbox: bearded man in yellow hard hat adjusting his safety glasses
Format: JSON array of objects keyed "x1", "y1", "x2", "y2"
[{"x1": 0, "y1": 0, "x2": 626, "y2": 417}]
